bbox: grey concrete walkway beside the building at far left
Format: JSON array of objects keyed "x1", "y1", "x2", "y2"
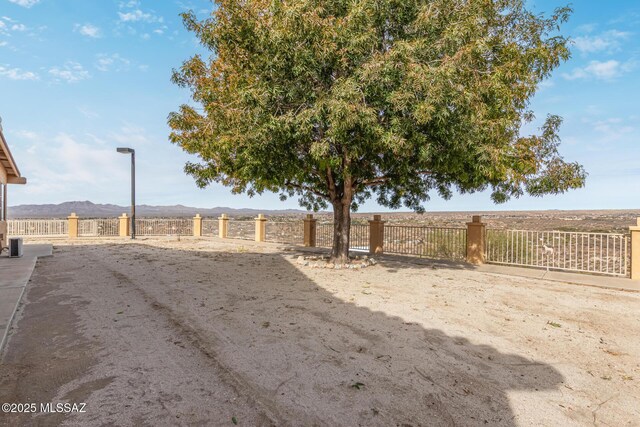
[{"x1": 0, "y1": 245, "x2": 53, "y2": 353}]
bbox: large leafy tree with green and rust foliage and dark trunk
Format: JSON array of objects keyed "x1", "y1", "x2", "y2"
[{"x1": 169, "y1": 0, "x2": 585, "y2": 262}]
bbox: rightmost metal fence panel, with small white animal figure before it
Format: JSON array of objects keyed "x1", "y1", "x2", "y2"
[{"x1": 486, "y1": 229, "x2": 630, "y2": 276}]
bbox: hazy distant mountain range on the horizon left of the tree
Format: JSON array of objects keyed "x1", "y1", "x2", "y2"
[{"x1": 7, "y1": 201, "x2": 306, "y2": 219}]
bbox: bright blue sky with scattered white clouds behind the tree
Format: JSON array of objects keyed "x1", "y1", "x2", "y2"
[{"x1": 0, "y1": 0, "x2": 640, "y2": 211}]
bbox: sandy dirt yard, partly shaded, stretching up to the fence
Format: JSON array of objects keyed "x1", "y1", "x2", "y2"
[{"x1": 0, "y1": 238, "x2": 640, "y2": 426}]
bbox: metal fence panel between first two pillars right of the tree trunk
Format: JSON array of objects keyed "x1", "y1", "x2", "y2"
[{"x1": 384, "y1": 225, "x2": 467, "y2": 260}]
